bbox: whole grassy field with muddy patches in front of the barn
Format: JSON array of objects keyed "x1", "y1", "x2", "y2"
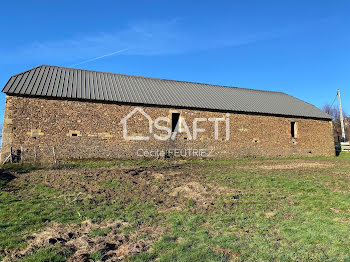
[{"x1": 0, "y1": 155, "x2": 350, "y2": 261}]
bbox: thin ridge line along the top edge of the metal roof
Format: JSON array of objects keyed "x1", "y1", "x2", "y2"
[{"x1": 38, "y1": 64, "x2": 286, "y2": 94}]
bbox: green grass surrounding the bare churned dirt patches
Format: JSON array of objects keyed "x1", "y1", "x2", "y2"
[{"x1": 0, "y1": 157, "x2": 350, "y2": 261}]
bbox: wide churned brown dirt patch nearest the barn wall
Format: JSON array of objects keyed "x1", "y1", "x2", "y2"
[{"x1": 17, "y1": 166, "x2": 238, "y2": 211}]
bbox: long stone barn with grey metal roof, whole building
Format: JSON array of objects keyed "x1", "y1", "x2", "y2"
[{"x1": 1, "y1": 65, "x2": 334, "y2": 161}]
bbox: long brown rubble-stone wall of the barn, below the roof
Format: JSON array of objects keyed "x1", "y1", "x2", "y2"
[{"x1": 1, "y1": 96, "x2": 334, "y2": 161}]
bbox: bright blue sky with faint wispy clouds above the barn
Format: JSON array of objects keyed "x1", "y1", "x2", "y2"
[{"x1": 0, "y1": 0, "x2": 350, "y2": 125}]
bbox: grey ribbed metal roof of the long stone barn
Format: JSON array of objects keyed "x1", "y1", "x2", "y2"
[{"x1": 2, "y1": 65, "x2": 331, "y2": 119}]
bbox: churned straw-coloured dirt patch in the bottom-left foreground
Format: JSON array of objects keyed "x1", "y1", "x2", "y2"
[{"x1": 4, "y1": 220, "x2": 159, "y2": 262}]
